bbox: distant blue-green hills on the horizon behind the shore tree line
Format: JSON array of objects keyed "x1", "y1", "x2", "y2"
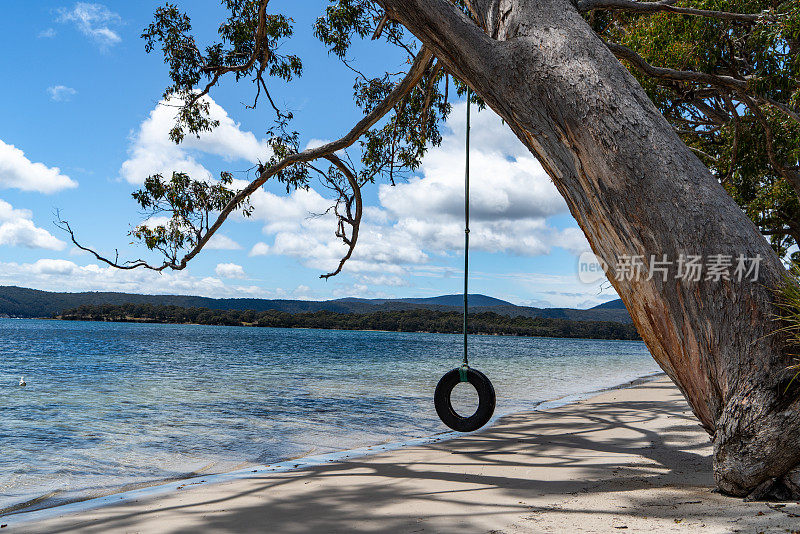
[{"x1": 0, "y1": 286, "x2": 631, "y2": 323}]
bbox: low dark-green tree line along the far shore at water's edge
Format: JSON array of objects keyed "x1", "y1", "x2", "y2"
[{"x1": 54, "y1": 304, "x2": 640, "y2": 340}]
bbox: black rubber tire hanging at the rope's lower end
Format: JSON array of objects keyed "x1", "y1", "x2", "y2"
[{"x1": 433, "y1": 368, "x2": 496, "y2": 432}]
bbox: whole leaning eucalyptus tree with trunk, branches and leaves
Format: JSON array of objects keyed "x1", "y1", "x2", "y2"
[{"x1": 64, "y1": 0, "x2": 800, "y2": 497}]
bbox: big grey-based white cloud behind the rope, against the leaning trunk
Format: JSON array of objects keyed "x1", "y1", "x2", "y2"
[{"x1": 378, "y1": 103, "x2": 567, "y2": 256}]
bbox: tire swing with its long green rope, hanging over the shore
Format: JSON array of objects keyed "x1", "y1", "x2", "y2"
[{"x1": 433, "y1": 89, "x2": 495, "y2": 432}]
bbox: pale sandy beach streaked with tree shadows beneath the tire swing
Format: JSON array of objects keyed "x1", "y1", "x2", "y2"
[{"x1": 7, "y1": 378, "x2": 800, "y2": 534}]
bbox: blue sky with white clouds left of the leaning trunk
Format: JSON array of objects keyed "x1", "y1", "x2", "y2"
[{"x1": 0, "y1": 0, "x2": 616, "y2": 308}]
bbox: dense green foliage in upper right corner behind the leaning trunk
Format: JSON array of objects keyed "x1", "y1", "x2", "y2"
[{"x1": 588, "y1": 0, "x2": 800, "y2": 259}]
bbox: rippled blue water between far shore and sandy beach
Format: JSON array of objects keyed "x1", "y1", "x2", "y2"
[{"x1": 0, "y1": 319, "x2": 658, "y2": 509}]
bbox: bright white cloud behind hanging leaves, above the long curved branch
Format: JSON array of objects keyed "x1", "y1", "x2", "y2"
[{"x1": 120, "y1": 97, "x2": 270, "y2": 184}]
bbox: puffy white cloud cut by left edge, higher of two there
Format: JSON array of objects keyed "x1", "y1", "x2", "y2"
[{"x1": 0, "y1": 141, "x2": 78, "y2": 193}]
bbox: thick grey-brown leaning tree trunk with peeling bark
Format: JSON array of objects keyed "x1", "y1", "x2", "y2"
[{"x1": 378, "y1": 0, "x2": 800, "y2": 497}]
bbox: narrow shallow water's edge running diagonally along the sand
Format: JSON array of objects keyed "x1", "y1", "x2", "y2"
[{"x1": 0, "y1": 372, "x2": 666, "y2": 528}]
